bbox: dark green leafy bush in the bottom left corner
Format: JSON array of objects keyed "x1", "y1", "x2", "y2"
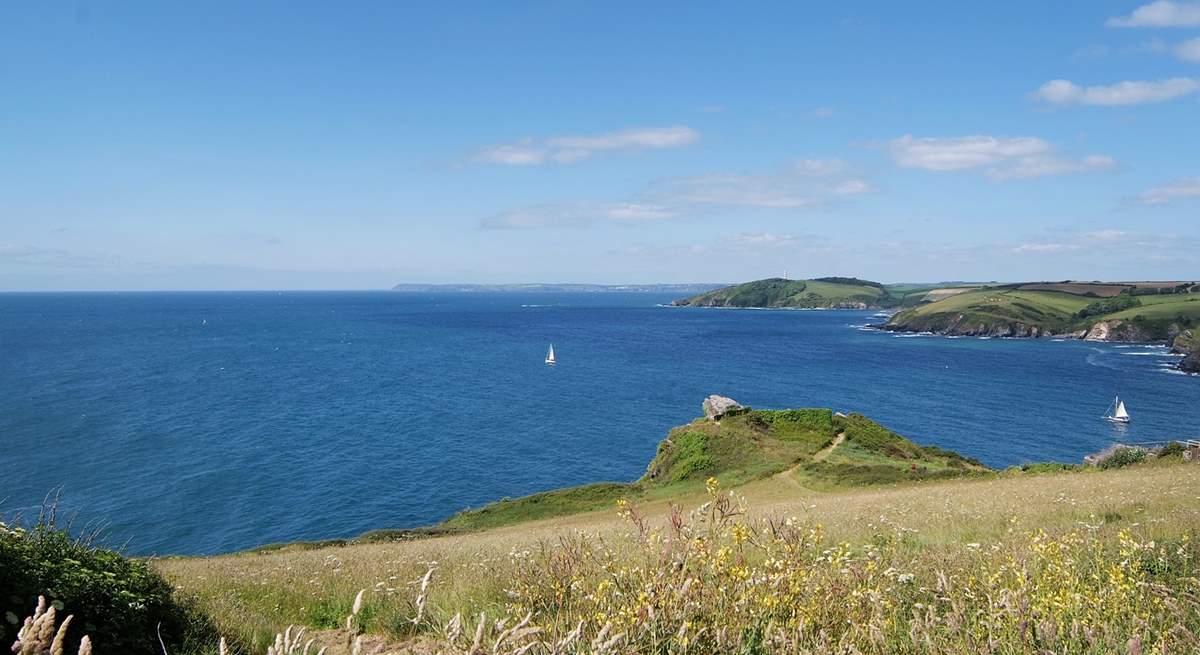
[{"x1": 0, "y1": 513, "x2": 218, "y2": 655}]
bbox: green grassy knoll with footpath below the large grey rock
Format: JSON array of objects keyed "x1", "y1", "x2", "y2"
[{"x1": 437, "y1": 409, "x2": 989, "y2": 530}]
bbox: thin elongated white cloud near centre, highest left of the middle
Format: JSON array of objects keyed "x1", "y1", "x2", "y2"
[{"x1": 473, "y1": 125, "x2": 700, "y2": 166}]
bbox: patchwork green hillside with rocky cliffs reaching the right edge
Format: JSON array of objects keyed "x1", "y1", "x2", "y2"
[{"x1": 887, "y1": 282, "x2": 1200, "y2": 341}]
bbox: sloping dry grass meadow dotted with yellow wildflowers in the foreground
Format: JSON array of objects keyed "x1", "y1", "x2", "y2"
[{"x1": 156, "y1": 463, "x2": 1200, "y2": 653}]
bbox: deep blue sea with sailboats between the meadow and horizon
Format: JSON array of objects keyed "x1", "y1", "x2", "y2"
[{"x1": 0, "y1": 292, "x2": 1200, "y2": 554}]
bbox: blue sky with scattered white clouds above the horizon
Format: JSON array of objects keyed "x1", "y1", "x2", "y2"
[{"x1": 0, "y1": 0, "x2": 1200, "y2": 290}]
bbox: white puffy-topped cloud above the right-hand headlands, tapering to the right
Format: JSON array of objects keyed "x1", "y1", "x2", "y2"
[{"x1": 888, "y1": 134, "x2": 1115, "y2": 180}]
